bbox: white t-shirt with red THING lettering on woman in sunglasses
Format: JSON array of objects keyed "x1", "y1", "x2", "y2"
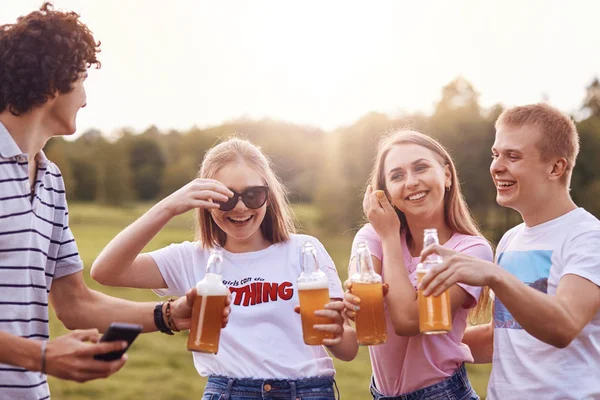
[{"x1": 149, "y1": 235, "x2": 343, "y2": 379}]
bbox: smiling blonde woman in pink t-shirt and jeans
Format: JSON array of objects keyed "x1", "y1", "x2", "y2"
[{"x1": 344, "y1": 131, "x2": 493, "y2": 400}]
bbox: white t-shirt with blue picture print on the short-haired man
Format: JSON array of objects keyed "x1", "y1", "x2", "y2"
[{"x1": 487, "y1": 208, "x2": 600, "y2": 400}]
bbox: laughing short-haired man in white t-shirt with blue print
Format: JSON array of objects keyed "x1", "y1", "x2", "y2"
[{"x1": 422, "y1": 104, "x2": 600, "y2": 400}]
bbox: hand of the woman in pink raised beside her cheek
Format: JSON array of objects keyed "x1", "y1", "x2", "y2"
[{"x1": 363, "y1": 185, "x2": 400, "y2": 238}]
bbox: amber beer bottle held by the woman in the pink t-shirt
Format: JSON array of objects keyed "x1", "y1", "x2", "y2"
[{"x1": 351, "y1": 243, "x2": 387, "y2": 346}]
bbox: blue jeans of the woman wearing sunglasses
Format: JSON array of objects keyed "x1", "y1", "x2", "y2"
[{"x1": 202, "y1": 376, "x2": 339, "y2": 400}]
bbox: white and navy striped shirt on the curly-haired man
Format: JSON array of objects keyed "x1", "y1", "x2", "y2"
[{"x1": 0, "y1": 123, "x2": 83, "y2": 400}]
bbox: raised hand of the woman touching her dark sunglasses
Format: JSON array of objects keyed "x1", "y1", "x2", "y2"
[{"x1": 163, "y1": 178, "x2": 233, "y2": 216}]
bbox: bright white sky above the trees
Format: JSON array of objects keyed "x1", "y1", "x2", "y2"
[{"x1": 0, "y1": 0, "x2": 600, "y2": 133}]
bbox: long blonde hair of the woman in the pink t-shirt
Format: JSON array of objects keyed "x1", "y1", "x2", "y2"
[{"x1": 369, "y1": 130, "x2": 489, "y2": 321}]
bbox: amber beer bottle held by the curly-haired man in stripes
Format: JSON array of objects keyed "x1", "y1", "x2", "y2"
[{"x1": 188, "y1": 249, "x2": 229, "y2": 354}]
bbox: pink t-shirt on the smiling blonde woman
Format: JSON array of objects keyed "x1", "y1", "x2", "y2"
[{"x1": 352, "y1": 224, "x2": 493, "y2": 396}]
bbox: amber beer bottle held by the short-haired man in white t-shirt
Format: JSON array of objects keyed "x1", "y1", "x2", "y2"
[{"x1": 417, "y1": 229, "x2": 452, "y2": 335}]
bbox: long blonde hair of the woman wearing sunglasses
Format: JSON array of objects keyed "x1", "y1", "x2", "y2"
[{"x1": 196, "y1": 137, "x2": 296, "y2": 248}]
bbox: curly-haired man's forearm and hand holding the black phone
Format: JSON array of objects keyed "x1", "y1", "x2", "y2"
[{"x1": 0, "y1": 329, "x2": 127, "y2": 382}]
